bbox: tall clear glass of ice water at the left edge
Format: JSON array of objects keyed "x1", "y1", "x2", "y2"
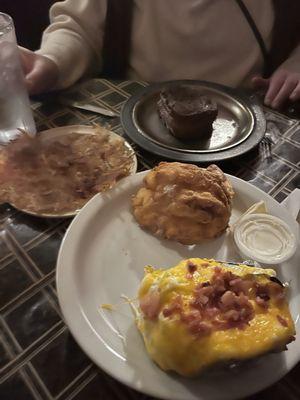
[{"x1": 0, "y1": 13, "x2": 36, "y2": 145}]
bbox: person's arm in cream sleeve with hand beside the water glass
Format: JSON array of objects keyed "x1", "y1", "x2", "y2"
[{"x1": 21, "y1": 0, "x2": 107, "y2": 94}]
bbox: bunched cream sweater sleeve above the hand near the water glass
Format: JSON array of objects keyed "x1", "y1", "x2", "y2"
[{"x1": 37, "y1": 0, "x2": 107, "y2": 89}]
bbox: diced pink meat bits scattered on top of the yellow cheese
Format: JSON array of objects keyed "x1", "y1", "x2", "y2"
[{"x1": 145, "y1": 262, "x2": 288, "y2": 336}]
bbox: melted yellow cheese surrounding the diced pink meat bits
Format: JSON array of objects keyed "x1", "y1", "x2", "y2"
[{"x1": 137, "y1": 258, "x2": 295, "y2": 376}]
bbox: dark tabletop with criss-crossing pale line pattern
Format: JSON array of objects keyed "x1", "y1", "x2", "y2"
[{"x1": 0, "y1": 80, "x2": 300, "y2": 400}]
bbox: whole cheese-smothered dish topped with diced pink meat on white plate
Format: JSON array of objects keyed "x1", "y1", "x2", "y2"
[{"x1": 137, "y1": 258, "x2": 295, "y2": 376}]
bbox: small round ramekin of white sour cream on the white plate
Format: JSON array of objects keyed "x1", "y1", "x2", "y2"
[{"x1": 234, "y1": 214, "x2": 297, "y2": 264}]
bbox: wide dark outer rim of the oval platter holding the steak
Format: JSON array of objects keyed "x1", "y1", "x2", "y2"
[{"x1": 120, "y1": 79, "x2": 266, "y2": 163}]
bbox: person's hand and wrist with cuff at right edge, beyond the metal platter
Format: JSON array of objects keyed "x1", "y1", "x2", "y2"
[{"x1": 252, "y1": 44, "x2": 300, "y2": 109}]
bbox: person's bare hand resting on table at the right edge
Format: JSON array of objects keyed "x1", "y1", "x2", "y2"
[{"x1": 252, "y1": 68, "x2": 300, "y2": 109}]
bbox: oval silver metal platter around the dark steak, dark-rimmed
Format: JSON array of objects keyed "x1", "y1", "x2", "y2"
[{"x1": 121, "y1": 80, "x2": 266, "y2": 162}]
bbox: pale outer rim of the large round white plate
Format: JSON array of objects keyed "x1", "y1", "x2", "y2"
[{"x1": 55, "y1": 170, "x2": 300, "y2": 400}]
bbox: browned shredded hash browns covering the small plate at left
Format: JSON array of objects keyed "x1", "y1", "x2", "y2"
[{"x1": 0, "y1": 127, "x2": 134, "y2": 214}]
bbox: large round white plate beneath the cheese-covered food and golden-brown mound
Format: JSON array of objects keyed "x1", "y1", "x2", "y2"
[{"x1": 57, "y1": 173, "x2": 300, "y2": 400}]
